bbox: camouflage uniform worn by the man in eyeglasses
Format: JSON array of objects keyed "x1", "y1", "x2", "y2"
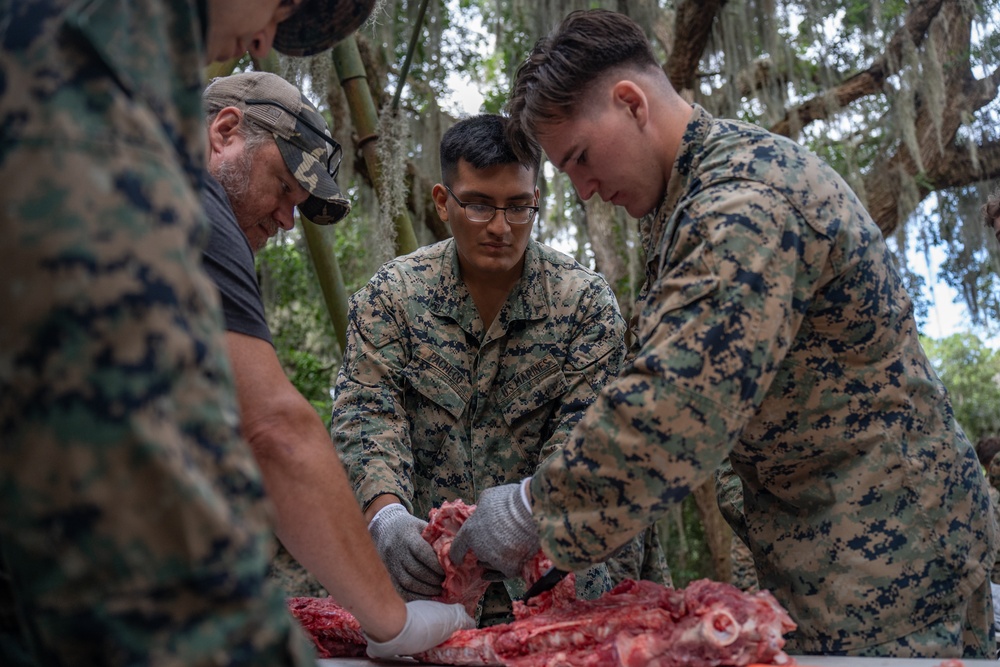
[{"x1": 331, "y1": 239, "x2": 668, "y2": 617}]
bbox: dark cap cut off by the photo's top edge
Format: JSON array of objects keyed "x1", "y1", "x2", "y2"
[{"x1": 274, "y1": 0, "x2": 375, "y2": 56}]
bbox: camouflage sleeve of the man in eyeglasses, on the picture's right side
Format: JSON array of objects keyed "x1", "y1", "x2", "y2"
[{"x1": 539, "y1": 278, "x2": 625, "y2": 461}]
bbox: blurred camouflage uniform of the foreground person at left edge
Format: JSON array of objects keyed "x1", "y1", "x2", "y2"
[{"x1": 0, "y1": 0, "x2": 315, "y2": 667}]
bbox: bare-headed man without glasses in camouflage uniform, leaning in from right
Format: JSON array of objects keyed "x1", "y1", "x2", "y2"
[{"x1": 452, "y1": 10, "x2": 996, "y2": 658}]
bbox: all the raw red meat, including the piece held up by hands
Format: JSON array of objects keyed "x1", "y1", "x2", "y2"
[{"x1": 289, "y1": 502, "x2": 795, "y2": 667}]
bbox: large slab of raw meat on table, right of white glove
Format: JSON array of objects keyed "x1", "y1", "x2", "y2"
[{"x1": 417, "y1": 580, "x2": 795, "y2": 667}]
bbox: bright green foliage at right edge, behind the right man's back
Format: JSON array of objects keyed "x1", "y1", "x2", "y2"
[{"x1": 921, "y1": 334, "x2": 1000, "y2": 444}]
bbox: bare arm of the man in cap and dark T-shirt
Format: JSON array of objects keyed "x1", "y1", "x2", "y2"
[{"x1": 226, "y1": 332, "x2": 406, "y2": 640}]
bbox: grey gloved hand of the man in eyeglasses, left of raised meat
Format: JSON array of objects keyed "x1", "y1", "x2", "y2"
[{"x1": 368, "y1": 503, "x2": 444, "y2": 601}]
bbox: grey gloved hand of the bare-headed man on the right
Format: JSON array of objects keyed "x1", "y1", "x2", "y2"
[{"x1": 451, "y1": 484, "x2": 539, "y2": 579}]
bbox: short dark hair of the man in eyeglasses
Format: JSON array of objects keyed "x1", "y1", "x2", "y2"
[{"x1": 441, "y1": 113, "x2": 542, "y2": 186}]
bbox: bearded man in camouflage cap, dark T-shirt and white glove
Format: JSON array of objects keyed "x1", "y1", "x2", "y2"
[{"x1": 203, "y1": 72, "x2": 472, "y2": 656}]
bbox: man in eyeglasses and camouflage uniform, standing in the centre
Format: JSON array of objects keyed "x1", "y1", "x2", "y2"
[{"x1": 331, "y1": 115, "x2": 668, "y2": 625}]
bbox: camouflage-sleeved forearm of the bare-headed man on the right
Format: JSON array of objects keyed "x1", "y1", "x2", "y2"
[{"x1": 531, "y1": 381, "x2": 742, "y2": 570}]
